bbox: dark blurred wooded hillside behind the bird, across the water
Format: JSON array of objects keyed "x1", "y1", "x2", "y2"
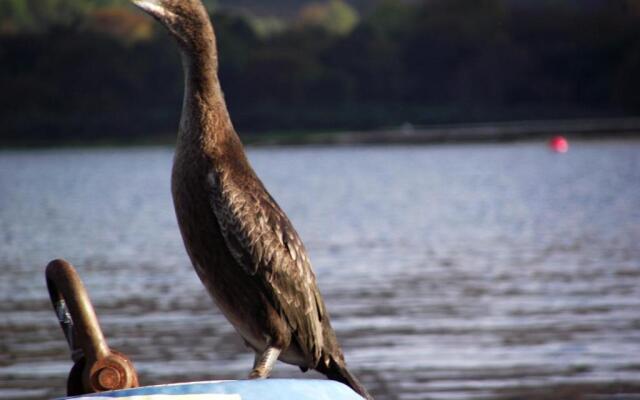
[{"x1": 0, "y1": 0, "x2": 640, "y2": 144}]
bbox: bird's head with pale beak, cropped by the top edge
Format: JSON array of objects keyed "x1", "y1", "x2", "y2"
[{"x1": 131, "y1": 0, "x2": 213, "y2": 50}]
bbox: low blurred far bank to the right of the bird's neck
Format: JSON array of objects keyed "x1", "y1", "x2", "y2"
[{"x1": 243, "y1": 118, "x2": 640, "y2": 145}]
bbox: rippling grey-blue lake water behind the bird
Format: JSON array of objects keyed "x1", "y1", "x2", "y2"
[{"x1": 0, "y1": 141, "x2": 640, "y2": 400}]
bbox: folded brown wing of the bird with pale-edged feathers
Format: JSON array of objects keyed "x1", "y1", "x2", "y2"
[{"x1": 210, "y1": 170, "x2": 325, "y2": 364}]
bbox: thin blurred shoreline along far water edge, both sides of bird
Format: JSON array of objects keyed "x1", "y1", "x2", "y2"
[{"x1": 0, "y1": 117, "x2": 640, "y2": 151}]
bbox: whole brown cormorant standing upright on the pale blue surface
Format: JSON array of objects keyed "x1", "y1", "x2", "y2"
[{"x1": 133, "y1": 0, "x2": 371, "y2": 398}]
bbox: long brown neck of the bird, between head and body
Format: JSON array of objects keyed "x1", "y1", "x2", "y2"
[{"x1": 178, "y1": 23, "x2": 235, "y2": 153}]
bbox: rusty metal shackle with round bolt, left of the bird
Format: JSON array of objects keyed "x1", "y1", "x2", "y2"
[{"x1": 46, "y1": 260, "x2": 139, "y2": 396}]
